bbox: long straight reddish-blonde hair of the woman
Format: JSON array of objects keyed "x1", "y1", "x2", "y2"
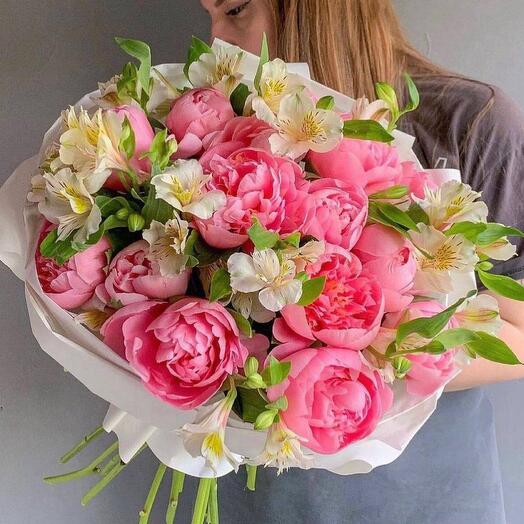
[{"x1": 267, "y1": 0, "x2": 449, "y2": 99}]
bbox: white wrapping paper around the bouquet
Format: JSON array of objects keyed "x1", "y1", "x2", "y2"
[{"x1": 0, "y1": 43, "x2": 466, "y2": 477}]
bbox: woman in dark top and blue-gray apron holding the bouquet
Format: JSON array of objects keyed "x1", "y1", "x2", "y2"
[{"x1": 198, "y1": 0, "x2": 524, "y2": 524}]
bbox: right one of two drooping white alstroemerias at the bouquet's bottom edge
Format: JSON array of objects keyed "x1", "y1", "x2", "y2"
[{"x1": 252, "y1": 422, "x2": 314, "y2": 475}]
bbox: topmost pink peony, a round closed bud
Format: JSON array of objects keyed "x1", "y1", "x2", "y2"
[{"x1": 166, "y1": 88, "x2": 235, "y2": 158}]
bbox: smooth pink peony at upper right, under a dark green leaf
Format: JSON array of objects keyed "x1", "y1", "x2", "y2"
[{"x1": 308, "y1": 138, "x2": 402, "y2": 195}]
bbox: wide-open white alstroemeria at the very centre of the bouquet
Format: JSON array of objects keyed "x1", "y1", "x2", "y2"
[{"x1": 227, "y1": 249, "x2": 302, "y2": 312}]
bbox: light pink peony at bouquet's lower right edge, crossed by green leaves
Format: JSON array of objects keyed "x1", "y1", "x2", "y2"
[{"x1": 384, "y1": 300, "x2": 458, "y2": 397}]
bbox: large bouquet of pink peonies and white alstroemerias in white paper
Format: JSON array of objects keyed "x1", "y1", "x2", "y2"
[{"x1": 0, "y1": 34, "x2": 524, "y2": 523}]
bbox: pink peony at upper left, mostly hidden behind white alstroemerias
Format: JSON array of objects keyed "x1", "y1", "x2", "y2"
[{"x1": 104, "y1": 106, "x2": 155, "y2": 191}]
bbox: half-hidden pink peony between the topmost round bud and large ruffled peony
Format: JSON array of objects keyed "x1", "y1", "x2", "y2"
[{"x1": 200, "y1": 116, "x2": 275, "y2": 171}]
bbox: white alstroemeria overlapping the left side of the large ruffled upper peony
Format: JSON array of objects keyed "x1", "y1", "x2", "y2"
[{"x1": 151, "y1": 160, "x2": 226, "y2": 219}]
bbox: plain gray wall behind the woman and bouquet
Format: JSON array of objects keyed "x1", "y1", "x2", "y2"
[{"x1": 0, "y1": 0, "x2": 524, "y2": 524}]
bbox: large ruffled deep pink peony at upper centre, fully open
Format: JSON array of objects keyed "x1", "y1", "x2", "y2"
[{"x1": 196, "y1": 149, "x2": 314, "y2": 249}]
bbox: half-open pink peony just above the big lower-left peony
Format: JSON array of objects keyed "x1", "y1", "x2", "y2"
[{"x1": 96, "y1": 240, "x2": 190, "y2": 307}]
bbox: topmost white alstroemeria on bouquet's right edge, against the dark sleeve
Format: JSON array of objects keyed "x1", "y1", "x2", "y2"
[{"x1": 417, "y1": 180, "x2": 488, "y2": 229}]
